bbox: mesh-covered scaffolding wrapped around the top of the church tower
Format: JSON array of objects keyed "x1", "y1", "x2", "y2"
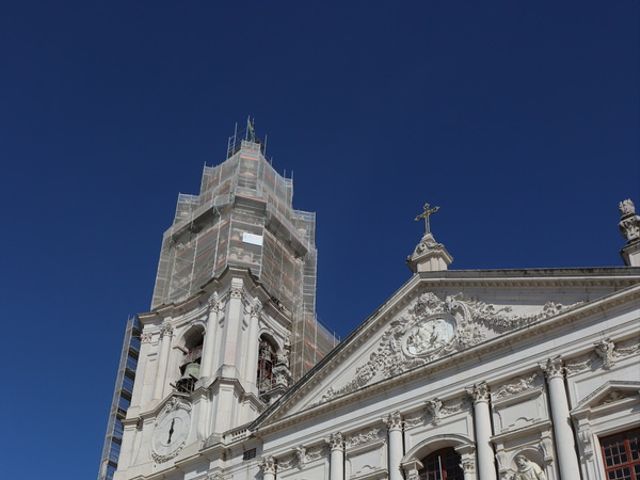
[{"x1": 151, "y1": 126, "x2": 336, "y2": 379}]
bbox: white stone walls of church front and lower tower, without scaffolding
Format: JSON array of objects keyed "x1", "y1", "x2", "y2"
[{"x1": 106, "y1": 145, "x2": 640, "y2": 480}]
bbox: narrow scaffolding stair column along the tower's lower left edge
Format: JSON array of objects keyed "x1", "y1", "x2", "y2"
[{"x1": 98, "y1": 317, "x2": 140, "y2": 480}]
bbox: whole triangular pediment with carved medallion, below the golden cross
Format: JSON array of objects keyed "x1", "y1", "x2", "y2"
[{"x1": 256, "y1": 272, "x2": 639, "y2": 432}]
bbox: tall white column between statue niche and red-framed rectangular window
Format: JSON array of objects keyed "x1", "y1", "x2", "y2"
[{"x1": 541, "y1": 357, "x2": 580, "y2": 480}]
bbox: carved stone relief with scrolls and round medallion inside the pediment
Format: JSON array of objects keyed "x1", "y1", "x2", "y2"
[{"x1": 318, "y1": 292, "x2": 570, "y2": 404}]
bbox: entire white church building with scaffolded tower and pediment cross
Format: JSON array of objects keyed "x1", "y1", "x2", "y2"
[{"x1": 99, "y1": 123, "x2": 640, "y2": 480}]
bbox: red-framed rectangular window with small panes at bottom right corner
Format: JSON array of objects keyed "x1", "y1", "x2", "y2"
[{"x1": 600, "y1": 429, "x2": 640, "y2": 480}]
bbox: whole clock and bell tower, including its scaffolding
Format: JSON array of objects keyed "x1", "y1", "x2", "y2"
[{"x1": 98, "y1": 120, "x2": 336, "y2": 480}]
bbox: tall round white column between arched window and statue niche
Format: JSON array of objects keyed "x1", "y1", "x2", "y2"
[{"x1": 467, "y1": 382, "x2": 496, "y2": 480}]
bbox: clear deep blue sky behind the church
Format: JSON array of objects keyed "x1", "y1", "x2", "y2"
[{"x1": 0, "y1": 0, "x2": 640, "y2": 480}]
